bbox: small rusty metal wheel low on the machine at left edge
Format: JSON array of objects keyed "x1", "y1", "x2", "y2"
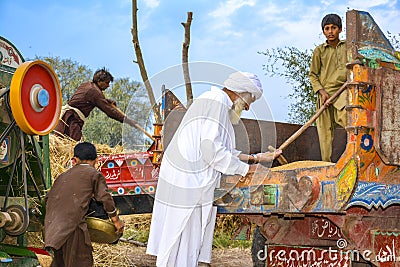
[{"x1": 3, "y1": 205, "x2": 29, "y2": 236}]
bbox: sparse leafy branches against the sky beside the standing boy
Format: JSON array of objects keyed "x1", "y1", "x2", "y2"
[{"x1": 259, "y1": 47, "x2": 317, "y2": 124}]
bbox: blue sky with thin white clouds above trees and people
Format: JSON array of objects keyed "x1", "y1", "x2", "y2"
[{"x1": 0, "y1": 0, "x2": 400, "y2": 121}]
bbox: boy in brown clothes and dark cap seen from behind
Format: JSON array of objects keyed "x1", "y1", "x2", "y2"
[{"x1": 45, "y1": 142, "x2": 124, "y2": 267}]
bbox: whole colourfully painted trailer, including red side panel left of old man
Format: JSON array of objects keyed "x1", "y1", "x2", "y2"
[{"x1": 98, "y1": 10, "x2": 400, "y2": 267}]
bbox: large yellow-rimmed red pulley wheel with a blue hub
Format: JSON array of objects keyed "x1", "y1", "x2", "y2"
[{"x1": 10, "y1": 60, "x2": 62, "y2": 135}]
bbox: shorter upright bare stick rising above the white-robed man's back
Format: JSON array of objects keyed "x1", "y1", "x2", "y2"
[{"x1": 182, "y1": 12, "x2": 193, "y2": 108}]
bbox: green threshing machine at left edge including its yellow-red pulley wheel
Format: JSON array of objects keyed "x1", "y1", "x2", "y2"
[{"x1": 0, "y1": 37, "x2": 62, "y2": 266}]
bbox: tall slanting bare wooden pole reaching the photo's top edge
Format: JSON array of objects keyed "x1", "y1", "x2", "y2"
[{"x1": 131, "y1": 0, "x2": 161, "y2": 123}]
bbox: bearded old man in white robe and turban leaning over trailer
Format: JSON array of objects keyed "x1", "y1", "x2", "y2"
[{"x1": 147, "y1": 72, "x2": 281, "y2": 267}]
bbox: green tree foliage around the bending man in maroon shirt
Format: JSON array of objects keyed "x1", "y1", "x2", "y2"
[{"x1": 35, "y1": 57, "x2": 150, "y2": 147}]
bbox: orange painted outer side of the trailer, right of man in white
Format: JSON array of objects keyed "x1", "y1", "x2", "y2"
[{"x1": 219, "y1": 10, "x2": 400, "y2": 266}]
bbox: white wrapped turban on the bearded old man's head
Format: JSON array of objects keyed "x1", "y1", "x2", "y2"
[{"x1": 224, "y1": 71, "x2": 262, "y2": 99}]
